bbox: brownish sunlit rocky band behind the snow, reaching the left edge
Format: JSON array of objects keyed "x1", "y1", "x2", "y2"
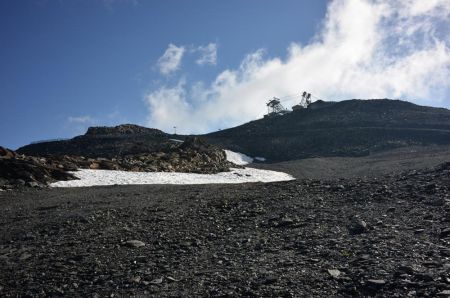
[{"x1": 0, "y1": 136, "x2": 234, "y2": 189}]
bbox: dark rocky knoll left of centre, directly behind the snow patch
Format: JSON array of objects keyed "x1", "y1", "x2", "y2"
[{"x1": 10, "y1": 134, "x2": 236, "y2": 185}]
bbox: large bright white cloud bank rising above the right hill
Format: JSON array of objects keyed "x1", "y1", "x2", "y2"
[{"x1": 146, "y1": 0, "x2": 450, "y2": 133}]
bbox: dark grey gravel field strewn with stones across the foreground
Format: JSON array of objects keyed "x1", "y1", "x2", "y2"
[{"x1": 0, "y1": 158, "x2": 450, "y2": 297}]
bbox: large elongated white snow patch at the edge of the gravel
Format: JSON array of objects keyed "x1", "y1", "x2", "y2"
[{"x1": 50, "y1": 168, "x2": 295, "y2": 187}]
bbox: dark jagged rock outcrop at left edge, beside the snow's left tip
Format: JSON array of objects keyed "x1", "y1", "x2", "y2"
[{"x1": 0, "y1": 147, "x2": 76, "y2": 189}]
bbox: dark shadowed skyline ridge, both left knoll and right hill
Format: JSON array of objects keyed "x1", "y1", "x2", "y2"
[{"x1": 17, "y1": 99, "x2": 450, "y2": 162}]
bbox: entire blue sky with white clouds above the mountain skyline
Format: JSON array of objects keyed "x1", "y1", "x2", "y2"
[{"x1": 0, "y1": 0, "x2": 450, "y2": 148}]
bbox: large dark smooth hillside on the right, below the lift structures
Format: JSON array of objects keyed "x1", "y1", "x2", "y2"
[{"x1": 204, "y1": 99, "x2": 450, "y2": 161}]
